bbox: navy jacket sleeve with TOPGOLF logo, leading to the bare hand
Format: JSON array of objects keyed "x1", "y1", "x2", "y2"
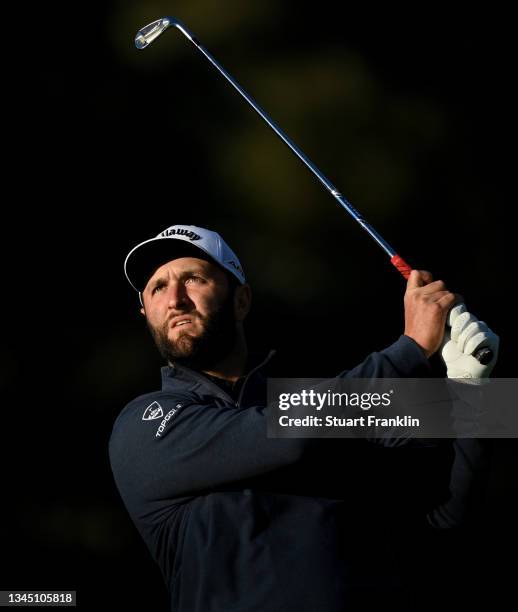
[{"x1": 110, "y1": 336, "x2": 434, "y2": 500}]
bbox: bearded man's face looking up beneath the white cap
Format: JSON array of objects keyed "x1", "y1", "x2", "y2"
[{"x1": 142, "y1": 257, "x2": 237, "y2": 369}]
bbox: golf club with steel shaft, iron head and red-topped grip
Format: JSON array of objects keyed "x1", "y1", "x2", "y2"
[{"x1": 135, "y1": 17, "x2": 493, "y2": 364}]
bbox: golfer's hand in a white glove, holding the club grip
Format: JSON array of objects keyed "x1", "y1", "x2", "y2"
[{"x1": 440, "y1": 304, "x2": 500, "y2": 378}]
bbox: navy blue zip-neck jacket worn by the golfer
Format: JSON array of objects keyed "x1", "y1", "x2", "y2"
[{"x1": 110, "y1": 336, "x2": 492, "y2": 612}]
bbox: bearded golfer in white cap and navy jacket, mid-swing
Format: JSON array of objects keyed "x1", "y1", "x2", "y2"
[{"x1": 109, "y1": 225, "x2": 496, "y2": 612}]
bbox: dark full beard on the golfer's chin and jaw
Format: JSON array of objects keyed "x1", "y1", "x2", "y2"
[{"x1": 148, "y1": 291, "x2": 237, "y2": 370}]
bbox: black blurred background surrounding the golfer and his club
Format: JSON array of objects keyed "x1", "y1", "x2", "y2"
[{"x1": 0, "y1": 0, "x2": 518, "y2": 610}]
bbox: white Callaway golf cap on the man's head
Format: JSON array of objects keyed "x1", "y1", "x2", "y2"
[{"x1": 124, "y1": 225, "x2": 246, "y2": 293}]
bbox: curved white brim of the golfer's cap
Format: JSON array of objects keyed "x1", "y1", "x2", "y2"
[{"x1": 124, "y1": 238, "x2": 217, "y2": 292}]
